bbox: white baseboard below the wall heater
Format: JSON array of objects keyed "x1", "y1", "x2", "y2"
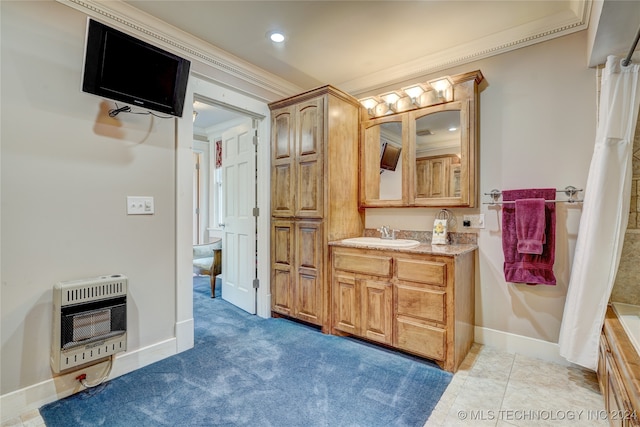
[{"x1": 0, "y1": 338, "x2": 176, "y2": 423}]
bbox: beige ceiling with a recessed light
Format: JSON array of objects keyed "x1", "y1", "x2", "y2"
[{"x1": 126, "y1": 0, "x2": 596, "y2": 92}]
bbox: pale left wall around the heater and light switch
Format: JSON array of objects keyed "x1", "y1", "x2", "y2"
[{"x1": 0, "y1": 1, "x2": 178, "y2": 417}]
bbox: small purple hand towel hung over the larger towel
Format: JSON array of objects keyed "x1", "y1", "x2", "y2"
[{"x1": 516, "y1": 199, "x2": 546, "y2": 255}]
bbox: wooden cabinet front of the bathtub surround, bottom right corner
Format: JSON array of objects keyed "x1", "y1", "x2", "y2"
[{"x1": 598, "y1": 307, "x2": 640, "y2": 427}]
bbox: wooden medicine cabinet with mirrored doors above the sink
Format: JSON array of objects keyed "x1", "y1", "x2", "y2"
[{"x1": 360, "y1": 71, "x2": 483, "y2": 207}]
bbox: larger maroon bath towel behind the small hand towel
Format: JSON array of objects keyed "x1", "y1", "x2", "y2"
[{"x1": 502, "y1": 188, "x2": 556, "y2": 285}]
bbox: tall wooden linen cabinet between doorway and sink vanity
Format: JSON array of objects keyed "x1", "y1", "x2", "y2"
[{"x1": 269, "y1": 86, "x2": 364, "y2": 332}]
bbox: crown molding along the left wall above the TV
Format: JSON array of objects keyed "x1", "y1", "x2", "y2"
[{"x1": 56, "y1": 0, "x2": 302, "y2": 102}]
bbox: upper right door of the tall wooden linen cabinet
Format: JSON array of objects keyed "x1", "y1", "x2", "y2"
[{"x1": 296, "y1": 98, "x2": 324, "y2": 218}]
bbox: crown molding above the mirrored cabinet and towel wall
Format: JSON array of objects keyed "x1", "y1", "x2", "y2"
[{"x1": 338, "y1": 0, "x2": 592, "y2": 97}]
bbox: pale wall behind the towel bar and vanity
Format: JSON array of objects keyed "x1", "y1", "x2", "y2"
[{"x1": 366, "y1": 32, "x2": 596, "y2": 352}]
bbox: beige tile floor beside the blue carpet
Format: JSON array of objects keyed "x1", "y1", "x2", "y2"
[{"x1": 2, "y1": 344, "x2": 608, "y2": 427}]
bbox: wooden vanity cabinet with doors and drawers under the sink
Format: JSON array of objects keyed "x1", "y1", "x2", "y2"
[{"x1": 331, "y1": 246, "x2": 475, "y2": 372}]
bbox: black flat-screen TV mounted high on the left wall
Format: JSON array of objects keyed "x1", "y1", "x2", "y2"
[{"x1": 82, "y1": 19, "x2": 191, "y2": 117}]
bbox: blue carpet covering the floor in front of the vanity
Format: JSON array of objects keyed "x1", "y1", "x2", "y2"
[{"x1": 40, "y1": 277, "x2": 451, "y2": 427}]
